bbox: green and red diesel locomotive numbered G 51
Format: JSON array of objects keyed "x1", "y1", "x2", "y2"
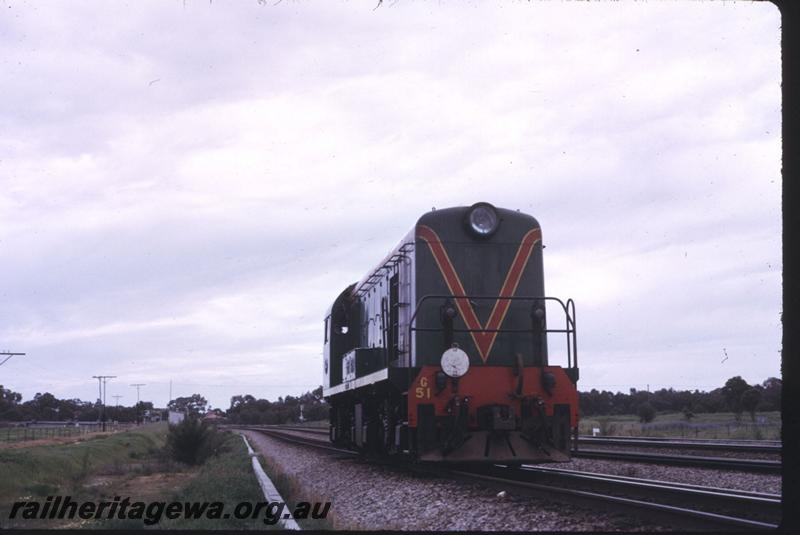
[{"x1": 323, "y1": 202, "x2": 578, "y2": 463}]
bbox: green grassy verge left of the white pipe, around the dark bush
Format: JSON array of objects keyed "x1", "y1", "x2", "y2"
[{"x1": 0, "y1": 424, "x2": 282, "y2": 530}]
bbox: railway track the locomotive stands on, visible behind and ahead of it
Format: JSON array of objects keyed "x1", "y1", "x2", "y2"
[{"x1": 236, "y1": 426, "x2": 781, "y2": 529}]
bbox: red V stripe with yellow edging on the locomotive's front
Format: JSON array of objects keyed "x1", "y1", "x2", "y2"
[{"x1": 417, "y1": 225, "x2": 542, "y2": 362}]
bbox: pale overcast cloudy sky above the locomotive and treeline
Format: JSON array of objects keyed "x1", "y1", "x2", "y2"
[{"x1": 0, "y1": 0, "x2": 782, "y2": 408}]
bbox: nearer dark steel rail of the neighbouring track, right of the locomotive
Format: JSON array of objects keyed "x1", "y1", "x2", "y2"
[{"x1": 572, "y1": 449, "x2": 782, "y2": 474}]
